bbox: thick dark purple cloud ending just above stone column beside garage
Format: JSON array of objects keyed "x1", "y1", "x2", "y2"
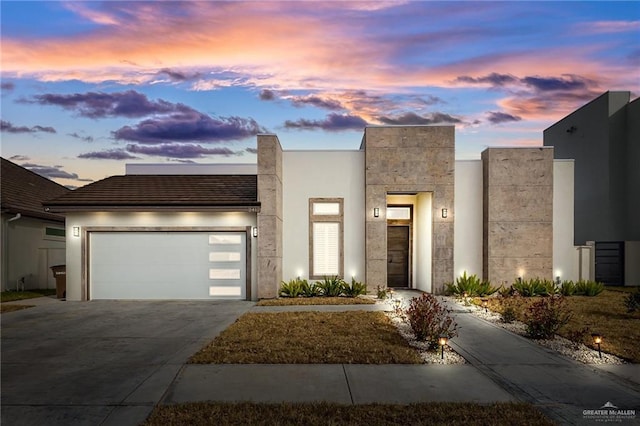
[{"x1": 112, "y1": 109, "x2": 266, "y2": 144}]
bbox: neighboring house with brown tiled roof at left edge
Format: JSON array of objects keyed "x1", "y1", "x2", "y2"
[{"x1": 0, "y1": 158, "x2": 71, "y2": 290}]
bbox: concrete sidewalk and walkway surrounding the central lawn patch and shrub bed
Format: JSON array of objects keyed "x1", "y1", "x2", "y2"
[{"x1": 161, "y1": 292, "x2": 640, "y2": 424}]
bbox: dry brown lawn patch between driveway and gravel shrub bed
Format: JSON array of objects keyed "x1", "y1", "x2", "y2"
[{"x1": 189, "y1": 311, "x2": 421, "y2": 364}]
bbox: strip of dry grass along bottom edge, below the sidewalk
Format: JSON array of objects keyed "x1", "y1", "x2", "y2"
[{"x1": 144, "y1": 402, "x2": 554, "y2": 426}]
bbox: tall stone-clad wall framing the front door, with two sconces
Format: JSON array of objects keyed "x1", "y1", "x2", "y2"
[{"x1": 363, "y1": 126, "x2": 455, "y2": 293}]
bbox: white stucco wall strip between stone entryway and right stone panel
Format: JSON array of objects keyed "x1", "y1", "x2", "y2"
[{"x1": 449, "y1": 160, "x2": 483, "y2": 277}]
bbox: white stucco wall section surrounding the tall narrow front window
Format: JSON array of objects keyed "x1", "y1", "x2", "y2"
[{"x1": 282, "y1": 151, "x2": 371, "y2": 282}]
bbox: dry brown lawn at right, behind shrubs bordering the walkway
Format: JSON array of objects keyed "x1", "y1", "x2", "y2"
[{"x1": 478, "y1": 290, "x2": 640, "y2": 363}]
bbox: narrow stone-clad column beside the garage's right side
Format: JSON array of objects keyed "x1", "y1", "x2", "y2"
[{"x1": 257, "y1": 135, "x2": 282, "y2": 299}]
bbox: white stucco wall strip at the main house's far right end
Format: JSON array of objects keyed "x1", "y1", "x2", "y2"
[{"x1": 553, "y1": 160, "x2": 579, "y2": 281}]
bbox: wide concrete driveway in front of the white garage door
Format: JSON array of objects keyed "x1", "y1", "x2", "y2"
[{"x1": 1, "y1": 298, "x2": 253, "y2": 426}]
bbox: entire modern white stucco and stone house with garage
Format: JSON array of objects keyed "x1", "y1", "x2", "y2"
[{"x1": 46, "y1": 126, "x2": 577, "y2": 300}]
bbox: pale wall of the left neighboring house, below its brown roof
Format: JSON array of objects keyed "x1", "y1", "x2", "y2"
[{"x1": 2, "y1": 215, "x2": 65, "y2": 290}]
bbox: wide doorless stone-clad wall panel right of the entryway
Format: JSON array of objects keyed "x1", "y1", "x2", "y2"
[{"x1": 482, "y1": 147, "x2": 553, "y2": 285}]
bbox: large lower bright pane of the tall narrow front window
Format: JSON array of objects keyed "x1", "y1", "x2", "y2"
[{"x1": 313, "y1": 222, "x2": 340, "y2": 275}]
